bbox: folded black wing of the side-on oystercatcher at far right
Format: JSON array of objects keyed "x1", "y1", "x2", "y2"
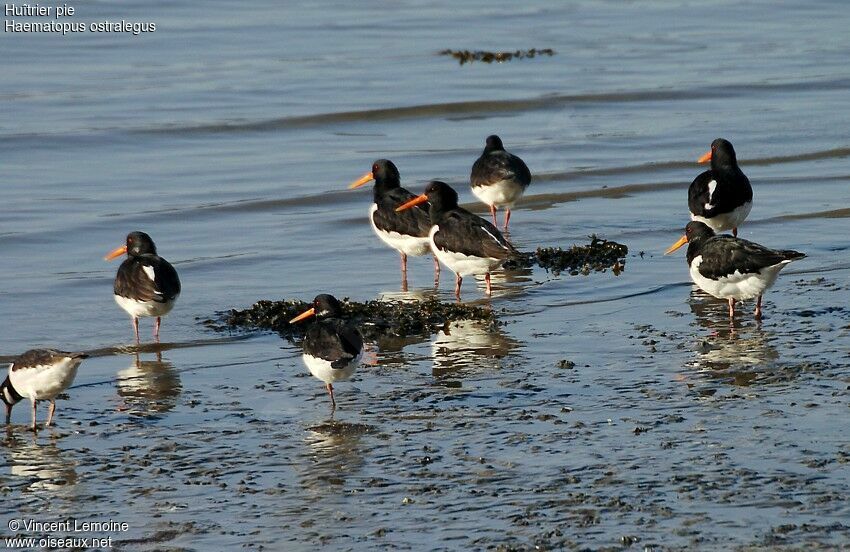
[{"x1": 688, "y1": 236, "x2": 806, "y2": 279}]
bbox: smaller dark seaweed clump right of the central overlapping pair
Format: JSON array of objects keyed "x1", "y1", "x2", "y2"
[{"x1": 505, "y1": 234, "x2": 629, "y2": 276}]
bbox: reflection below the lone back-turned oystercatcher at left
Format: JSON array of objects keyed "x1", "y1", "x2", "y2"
[{"x1": 116, "y1": 351, "x2": 182, "y2": 416}]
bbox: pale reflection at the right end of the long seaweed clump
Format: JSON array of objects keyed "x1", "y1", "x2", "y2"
[{"x1": 431, "y1": 320, "x2": 520, "y2": 378}]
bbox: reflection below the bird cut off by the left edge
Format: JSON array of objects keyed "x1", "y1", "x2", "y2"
[{"x1": 3, "y1": 428, "x2": 77, "y2": 499}]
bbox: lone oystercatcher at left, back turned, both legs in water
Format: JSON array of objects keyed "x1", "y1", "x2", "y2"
[{"x1": 105, "y1": 232, "x2": 180, "y2": 343}]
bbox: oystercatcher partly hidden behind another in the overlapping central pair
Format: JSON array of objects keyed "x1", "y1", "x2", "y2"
[{"x1": 348, "y1": 159, "x2": 440, "y2": 282}]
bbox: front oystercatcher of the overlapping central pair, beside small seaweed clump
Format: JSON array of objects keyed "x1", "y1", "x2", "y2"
[{"x1": 396, "y1": 180, "x2": 517, "y2": 299}]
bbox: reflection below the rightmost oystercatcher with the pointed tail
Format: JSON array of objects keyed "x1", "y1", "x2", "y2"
[{"x1": 689, "y1": 289, "x2": 779, "y2": 385}]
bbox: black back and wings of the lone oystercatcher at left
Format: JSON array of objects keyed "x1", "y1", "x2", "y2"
[{"x1": 113, "y1": 255, "x2": 180, "y2": 303}]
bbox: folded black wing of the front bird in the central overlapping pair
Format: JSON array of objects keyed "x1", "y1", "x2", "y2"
[{"x1": 434, "y1": 208, "x2": 517, "y2": 259}]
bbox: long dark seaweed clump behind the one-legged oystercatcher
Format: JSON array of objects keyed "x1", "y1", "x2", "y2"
[{"x1": 204, "y1": 298, "x2": 499, "y2": 340}]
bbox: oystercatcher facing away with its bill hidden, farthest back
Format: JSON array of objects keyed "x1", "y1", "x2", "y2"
[{"x1": 469, "y1": 134, "x2": 531, "y2": 230}]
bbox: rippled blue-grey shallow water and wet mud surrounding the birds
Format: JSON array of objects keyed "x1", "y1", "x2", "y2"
[{"x1": 0, "y1": 1, "x2": 850, "y2": 550}]
